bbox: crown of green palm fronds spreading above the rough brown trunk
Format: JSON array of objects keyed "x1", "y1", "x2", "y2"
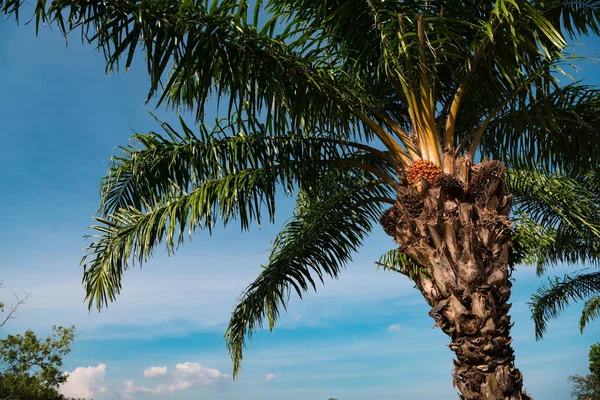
[{"x1": 0, "y1": 0, "x2": 600, "y2": 398}]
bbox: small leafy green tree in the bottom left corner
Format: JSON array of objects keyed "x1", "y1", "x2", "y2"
[{"x1": 0, "y1": 326, "x2": 75, "y2": 400}]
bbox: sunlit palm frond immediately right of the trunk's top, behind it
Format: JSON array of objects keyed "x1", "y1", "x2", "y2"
[{"x1": 506, "y1": 168, "x2": 600, "y2": 274}]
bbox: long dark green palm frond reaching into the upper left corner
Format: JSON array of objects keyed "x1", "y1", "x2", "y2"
[{"x1": 2, "y1": 0, "x2": 377, "y2": 143}]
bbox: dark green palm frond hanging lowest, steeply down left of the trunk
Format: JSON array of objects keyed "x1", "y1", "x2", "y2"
[{"x1": 225, "y1": 173, "x2": 389, "y2": 376}]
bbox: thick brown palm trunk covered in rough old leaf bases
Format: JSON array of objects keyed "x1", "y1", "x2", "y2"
[{"x1": 381, "y1": 162, "x2": 530, "y2": 400}]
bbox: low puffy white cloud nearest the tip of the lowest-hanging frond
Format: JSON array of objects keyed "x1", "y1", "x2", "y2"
[{"x1": 124, "y1": 362, "x2": 228, "y2": 396}]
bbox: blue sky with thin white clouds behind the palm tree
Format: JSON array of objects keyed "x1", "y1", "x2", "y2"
[{"x1": 0, "y1": 12, "x2": 600, "y2": 400}]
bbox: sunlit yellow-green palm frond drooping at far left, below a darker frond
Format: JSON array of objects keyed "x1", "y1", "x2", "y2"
[{"x1": 82, "y1": 168, "x2": 282, "y2": 309}]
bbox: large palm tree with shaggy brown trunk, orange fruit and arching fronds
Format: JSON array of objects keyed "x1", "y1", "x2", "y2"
[{"x1": 0, "y1": 0, "x2": 600, "y2": 400}]
